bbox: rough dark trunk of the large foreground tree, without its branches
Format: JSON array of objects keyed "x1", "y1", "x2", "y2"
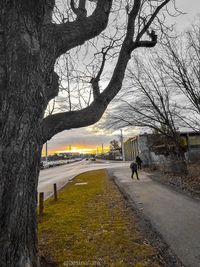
[{"x1": 0, "y1": 1, "x2": 45, "y2": 267}]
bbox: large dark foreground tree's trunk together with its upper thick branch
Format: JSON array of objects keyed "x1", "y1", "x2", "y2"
[{"x1": 0, "y1": 0, "x2": 112, "y2": 267}]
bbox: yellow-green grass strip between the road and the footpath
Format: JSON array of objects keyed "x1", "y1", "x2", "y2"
[{"x1": 38, "y1": 170, "x2": 159, "y2": 267}]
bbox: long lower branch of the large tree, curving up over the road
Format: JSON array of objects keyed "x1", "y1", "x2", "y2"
[{"x1": 43, "y1": 0, "x2": 171, "y2": 142}]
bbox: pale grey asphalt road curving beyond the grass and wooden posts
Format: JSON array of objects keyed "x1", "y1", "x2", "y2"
[{"x1": 38, "y1": 160, "x2": 130, "y2": 199}]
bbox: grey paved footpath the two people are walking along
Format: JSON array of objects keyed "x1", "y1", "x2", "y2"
[{"x1": 110, "y1": 168, "x2": 200, "y2": 267}]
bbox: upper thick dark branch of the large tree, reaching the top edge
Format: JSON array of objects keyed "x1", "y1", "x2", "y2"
[{"x1": 50, "y1": 0, "x2": 112, "y2": 57}]
